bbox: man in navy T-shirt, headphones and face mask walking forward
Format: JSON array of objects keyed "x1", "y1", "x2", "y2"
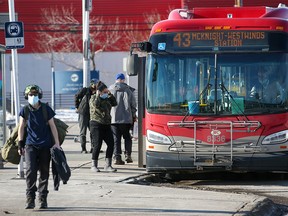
[{"x1": 18, "y1": 85, "x2": 60, "y2": 209}]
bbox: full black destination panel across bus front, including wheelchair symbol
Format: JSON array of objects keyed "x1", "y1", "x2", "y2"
[{"x1": 150, "y1": 30, "x2": 288, "y2": 52}]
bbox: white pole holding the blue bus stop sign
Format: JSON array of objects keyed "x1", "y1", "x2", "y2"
[{"x1": 9, "y1": 0, "x2": 24, "y2": 178}]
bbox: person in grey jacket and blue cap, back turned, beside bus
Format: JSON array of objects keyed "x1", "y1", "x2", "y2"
[{"x1": 109, "y1": 73, "x2": 137, "y2": 165}]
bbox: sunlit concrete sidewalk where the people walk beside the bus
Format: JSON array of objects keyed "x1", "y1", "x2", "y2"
[{"x1": 0, "y1": 123, "x2": 275, "y2": 216}]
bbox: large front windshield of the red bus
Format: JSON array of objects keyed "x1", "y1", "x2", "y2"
[{"x1": 146, "y1": 52, "x2": 288, "y2": 115}]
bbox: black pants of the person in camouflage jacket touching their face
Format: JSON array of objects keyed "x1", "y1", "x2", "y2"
[{"x1": 90, "y1": 121, "x2": 114, "y2": 160}]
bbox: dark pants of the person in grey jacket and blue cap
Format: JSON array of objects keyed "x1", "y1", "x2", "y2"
[{"x1": 111, "y1": 124, "x2": 132, "y2": 159}]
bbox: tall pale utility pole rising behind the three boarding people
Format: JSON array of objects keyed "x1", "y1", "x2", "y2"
[{"x1": 82, "y1": 0, "x2": 92, "y2": 87}]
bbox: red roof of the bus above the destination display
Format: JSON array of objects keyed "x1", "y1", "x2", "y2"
[{"x1": 151, "y1": 6, "x2": 288, "y2": 35}]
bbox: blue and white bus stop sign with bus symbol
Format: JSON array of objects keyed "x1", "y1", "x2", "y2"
[{"x1": 5, "y1": 22, "x2": 24, "y2": 49}]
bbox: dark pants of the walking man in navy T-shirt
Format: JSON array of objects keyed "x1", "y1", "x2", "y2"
[{"x1": 25, "y1": 145, "x2": 51, "y2": 199}]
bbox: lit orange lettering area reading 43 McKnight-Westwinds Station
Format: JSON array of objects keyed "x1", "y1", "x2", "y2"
[{"x1": 173, "y1": 31, "x2": 268, "y2": 49}]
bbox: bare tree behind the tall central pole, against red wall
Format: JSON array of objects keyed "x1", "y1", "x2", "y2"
[{"x1": 35, "y1": 6, "x2": 123, "y2": 70}]
